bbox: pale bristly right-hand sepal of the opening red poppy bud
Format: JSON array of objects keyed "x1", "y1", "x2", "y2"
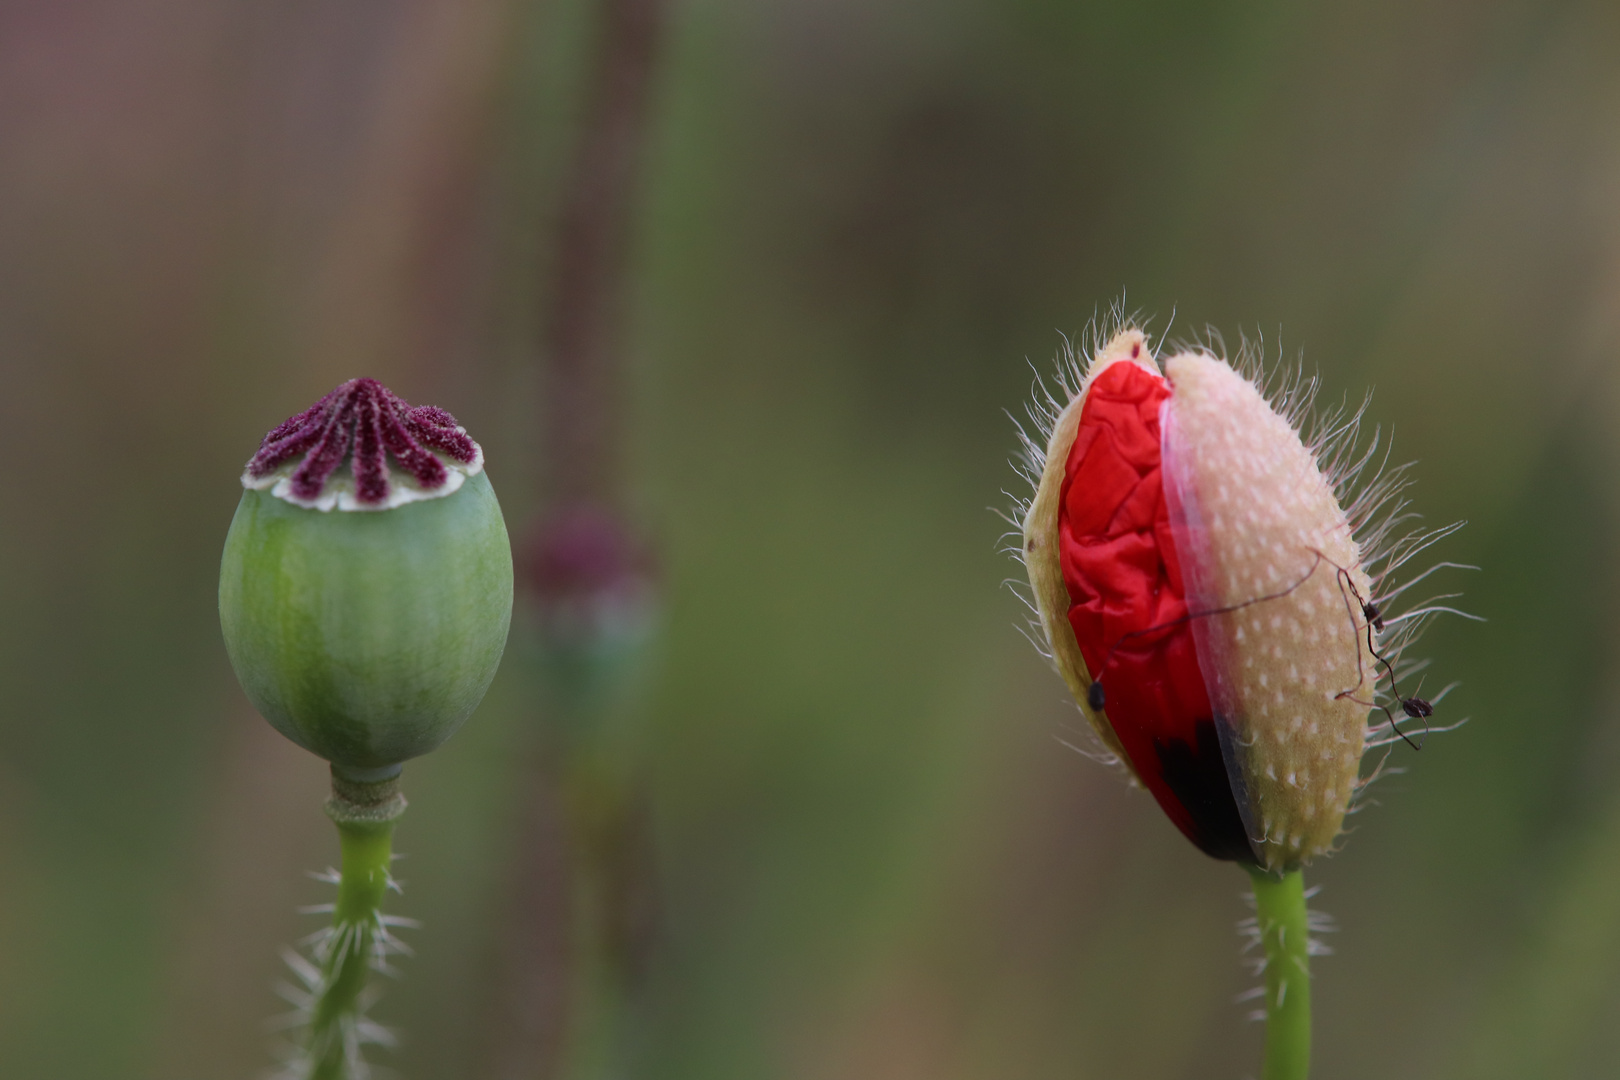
[{"x1": 1162, "y1": 353, "x2": 1375, "y2": 871}]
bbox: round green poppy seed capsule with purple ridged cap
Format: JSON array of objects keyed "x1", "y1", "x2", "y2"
[{"x1": 219, "y1": 379, "x2": 512, "y2": 780}]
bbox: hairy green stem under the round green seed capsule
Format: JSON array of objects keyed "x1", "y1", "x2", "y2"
[{"x1": 308, "y1": 769, "x2": 405, "y2": 1080}]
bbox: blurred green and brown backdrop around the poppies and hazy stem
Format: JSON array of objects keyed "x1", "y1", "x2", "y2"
[{"x1": 0, "y1": 0, "x2": 1620, "y2": 1080}]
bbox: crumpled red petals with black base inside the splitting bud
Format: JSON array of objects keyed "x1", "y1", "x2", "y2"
[{"x1": 1058, "y1": 361, "x2": 1254, "y2": 861}]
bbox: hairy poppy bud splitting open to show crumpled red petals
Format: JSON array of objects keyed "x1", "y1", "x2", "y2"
[{"x1": 1022, "y1": 329, "x2": 1382, "y2": 871}]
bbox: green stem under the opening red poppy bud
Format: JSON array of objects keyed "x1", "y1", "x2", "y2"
[{"x1": 1251, "y1": 870, "x2": 1311, "y2": 1080}]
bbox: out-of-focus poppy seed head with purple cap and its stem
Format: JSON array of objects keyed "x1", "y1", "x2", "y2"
[{"x1": 518, "y1": 518, "x2": 656, "y2": 1080}]
